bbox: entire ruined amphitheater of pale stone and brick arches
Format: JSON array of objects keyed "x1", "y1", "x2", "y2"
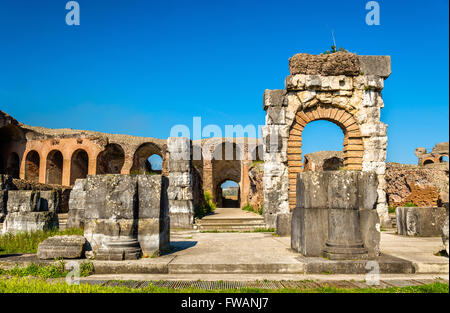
[{"x1": 0, "y1": 52, "x2": 448, "y2": 259}]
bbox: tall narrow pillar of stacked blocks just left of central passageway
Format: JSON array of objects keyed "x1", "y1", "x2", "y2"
[{"x1": 167, "y1": 137, "x2": 194, "y2": 228}]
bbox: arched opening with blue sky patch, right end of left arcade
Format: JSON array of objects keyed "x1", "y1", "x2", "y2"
[{"x1": 131, "y1": 142, "x2": 163, "y2": 174}]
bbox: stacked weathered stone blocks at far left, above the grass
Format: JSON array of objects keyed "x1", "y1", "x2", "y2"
[{"x1": 3, "y1": 190, "x2": 58, "y2": 233}]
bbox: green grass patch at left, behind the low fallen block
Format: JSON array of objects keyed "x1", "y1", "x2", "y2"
[{"x1": 0, "y1": 228, "x2": 84, "y2": 254}]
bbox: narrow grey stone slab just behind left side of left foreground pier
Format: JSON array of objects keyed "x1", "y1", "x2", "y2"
[{"x1": 67, "y1": 179, "x2": 87, "y2": 228}]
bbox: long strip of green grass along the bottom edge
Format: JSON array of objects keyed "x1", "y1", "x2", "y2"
[{"x1": 0, "y1": 277, "x2": 449, "y2": 293}]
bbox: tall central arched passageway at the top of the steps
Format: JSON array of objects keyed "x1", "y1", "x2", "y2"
[{"x1": 212, "y1": 142, "x2": 241, "y2": 207}]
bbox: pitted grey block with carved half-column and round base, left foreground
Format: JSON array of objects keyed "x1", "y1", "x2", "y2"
[{"x1": 84, "y1": 175, "x2": 141, "y2": 261}]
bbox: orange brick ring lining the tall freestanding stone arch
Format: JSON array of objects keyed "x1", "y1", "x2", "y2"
[{"x1": 287, "y1": 106, "x2": 364, "y2": 209}]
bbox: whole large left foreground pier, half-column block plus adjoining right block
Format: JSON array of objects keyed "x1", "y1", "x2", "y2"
[{"x1": 84, "y1": 175, "x2": 170, "y2": 260}]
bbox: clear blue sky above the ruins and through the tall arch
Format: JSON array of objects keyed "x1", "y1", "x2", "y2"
[{"x1": 0, "y1": 0, "x2": 449, "y2": 163}]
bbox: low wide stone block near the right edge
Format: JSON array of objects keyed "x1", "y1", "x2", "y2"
[{"x1": 395, "y1": 207, "x2": 448, "y2": 237}]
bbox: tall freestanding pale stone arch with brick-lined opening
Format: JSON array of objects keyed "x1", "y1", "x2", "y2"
[{"x1": 263, "y1": 52, "x2": 391, "y2": 227}]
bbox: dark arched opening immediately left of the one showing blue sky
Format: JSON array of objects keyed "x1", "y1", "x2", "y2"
[{"x1": 97, "y1": 143, "x2": 125, "y2": 174}]
